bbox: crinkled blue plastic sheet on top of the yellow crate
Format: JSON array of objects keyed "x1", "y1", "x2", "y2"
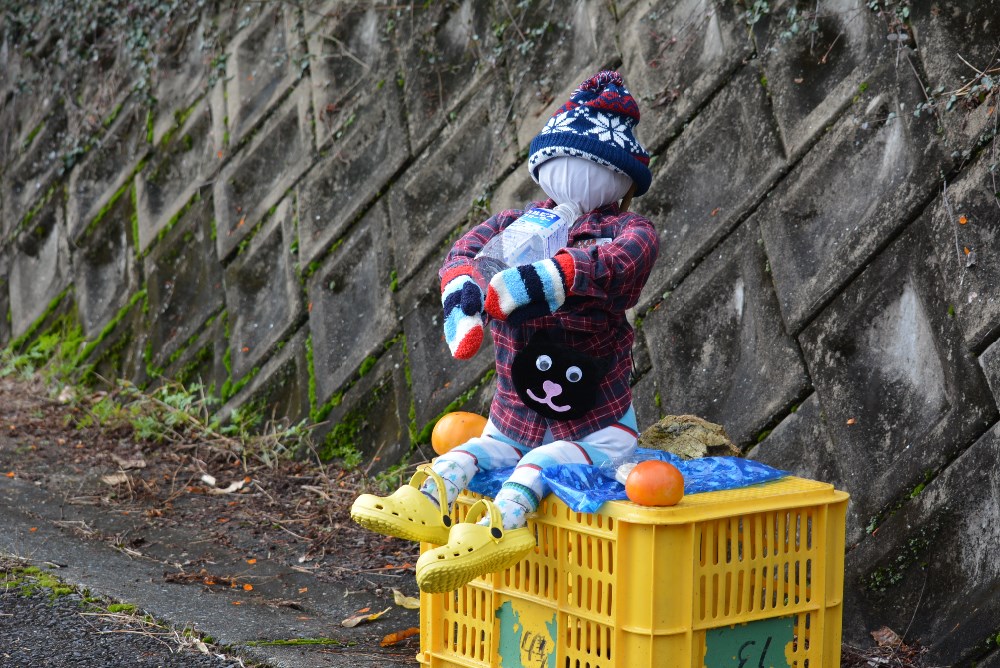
[{"x1": 469, "y1": 448, "x2": 788, "y2": 513}]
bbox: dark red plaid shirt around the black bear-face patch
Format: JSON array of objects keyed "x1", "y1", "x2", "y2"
[{"x1": 440, "y1": 199, "x2": 659, "y2": 447}]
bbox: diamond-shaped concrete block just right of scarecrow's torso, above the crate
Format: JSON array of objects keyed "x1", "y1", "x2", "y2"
[{"x1": 642, "y1": 221, "x2": 810, "y2": 448}]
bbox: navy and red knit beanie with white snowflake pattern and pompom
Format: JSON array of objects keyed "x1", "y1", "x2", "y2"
[{"x1": 528, "y1": 71, "x2": 653, "y2": 196}]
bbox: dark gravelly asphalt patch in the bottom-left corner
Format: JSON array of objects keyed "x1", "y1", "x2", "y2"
[{"x1": 0, "y1": 560, "x2": 243, "y2": 668}]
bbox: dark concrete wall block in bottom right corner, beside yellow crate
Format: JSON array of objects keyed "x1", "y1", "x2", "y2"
[{"x1": 844, "y1": 427, "x2": 1000, "y2": 665}]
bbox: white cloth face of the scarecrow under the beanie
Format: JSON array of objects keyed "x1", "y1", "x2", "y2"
[{"x1": 538, "y1": 156, "x2": 632, "y2": 214}]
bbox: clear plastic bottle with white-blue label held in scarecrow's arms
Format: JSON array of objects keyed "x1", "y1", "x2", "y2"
[{"x1": 475, "y1": 204, "x2": 580, "y2": 291}]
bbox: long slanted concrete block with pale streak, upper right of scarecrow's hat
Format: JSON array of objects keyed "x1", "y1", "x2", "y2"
[{"x1": 760, "y1": 56, "x2": 944, "y2": 332}]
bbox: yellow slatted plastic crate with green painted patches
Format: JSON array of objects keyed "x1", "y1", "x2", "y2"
[{"x1": 417, "y1": 477, "x2": 848, "y2": 668}]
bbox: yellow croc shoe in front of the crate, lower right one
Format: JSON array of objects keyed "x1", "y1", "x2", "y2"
[{"x1": 417, "y1": 499, "x2": 535, "y2": 594}]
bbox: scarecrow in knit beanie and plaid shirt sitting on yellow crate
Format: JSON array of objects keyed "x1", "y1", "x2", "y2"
[{"x1": 351, "y1": 71, "x2": 659, "y2": 592}]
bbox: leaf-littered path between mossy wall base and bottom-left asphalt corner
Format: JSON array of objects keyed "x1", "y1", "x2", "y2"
[{"x1": 0, "y1": 378, "x2": 419, "y2": 666}]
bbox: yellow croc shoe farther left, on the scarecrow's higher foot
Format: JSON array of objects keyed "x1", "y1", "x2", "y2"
[{"x1": 351, "y1": 464, "x2": 451, "y2": 545}]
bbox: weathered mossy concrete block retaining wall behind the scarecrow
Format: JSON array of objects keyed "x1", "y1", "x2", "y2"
[{"x1": 0, "y1": 0, "x2": 1000, "y2": 665}]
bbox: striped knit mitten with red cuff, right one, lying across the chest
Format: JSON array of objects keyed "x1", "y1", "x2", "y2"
[{"x1": 486, "y1": 252, "x2": 575, "y2": 325}]
